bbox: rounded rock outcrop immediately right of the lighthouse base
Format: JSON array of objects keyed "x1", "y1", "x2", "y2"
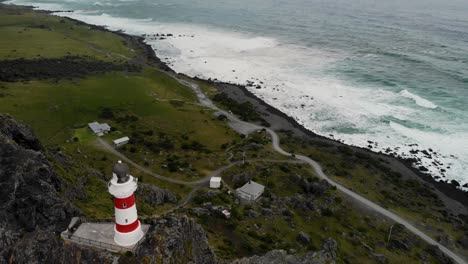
[{"x1": 136, "y1": 216, "x2": 217, "y2": 264}]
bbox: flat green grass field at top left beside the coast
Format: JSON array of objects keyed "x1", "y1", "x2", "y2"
[{"x1": 0, "y1": 7, "x2": 136, "y2": 60}]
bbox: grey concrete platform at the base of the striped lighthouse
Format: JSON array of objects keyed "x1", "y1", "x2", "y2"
[{"x1": 61, "y1": 223, "x2": 150, "y2": 252}]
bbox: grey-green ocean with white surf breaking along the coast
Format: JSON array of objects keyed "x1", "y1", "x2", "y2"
[{"x1": 7, "y1": 0, "x2": 468, "y2": 190}]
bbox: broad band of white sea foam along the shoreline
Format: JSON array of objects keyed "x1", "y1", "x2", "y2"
[{"x1": 2, "y1": 4, "x2": 468, "y2": 190}]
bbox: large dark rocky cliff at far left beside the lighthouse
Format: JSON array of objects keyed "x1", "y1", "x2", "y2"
[{"x1": 0, "y1": 114, "x2": 109, "y2": 263}]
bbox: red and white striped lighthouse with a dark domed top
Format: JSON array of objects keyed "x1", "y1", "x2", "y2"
[{"x1": 109, "y1": 161, "x2": 143, "y2": 247}]
